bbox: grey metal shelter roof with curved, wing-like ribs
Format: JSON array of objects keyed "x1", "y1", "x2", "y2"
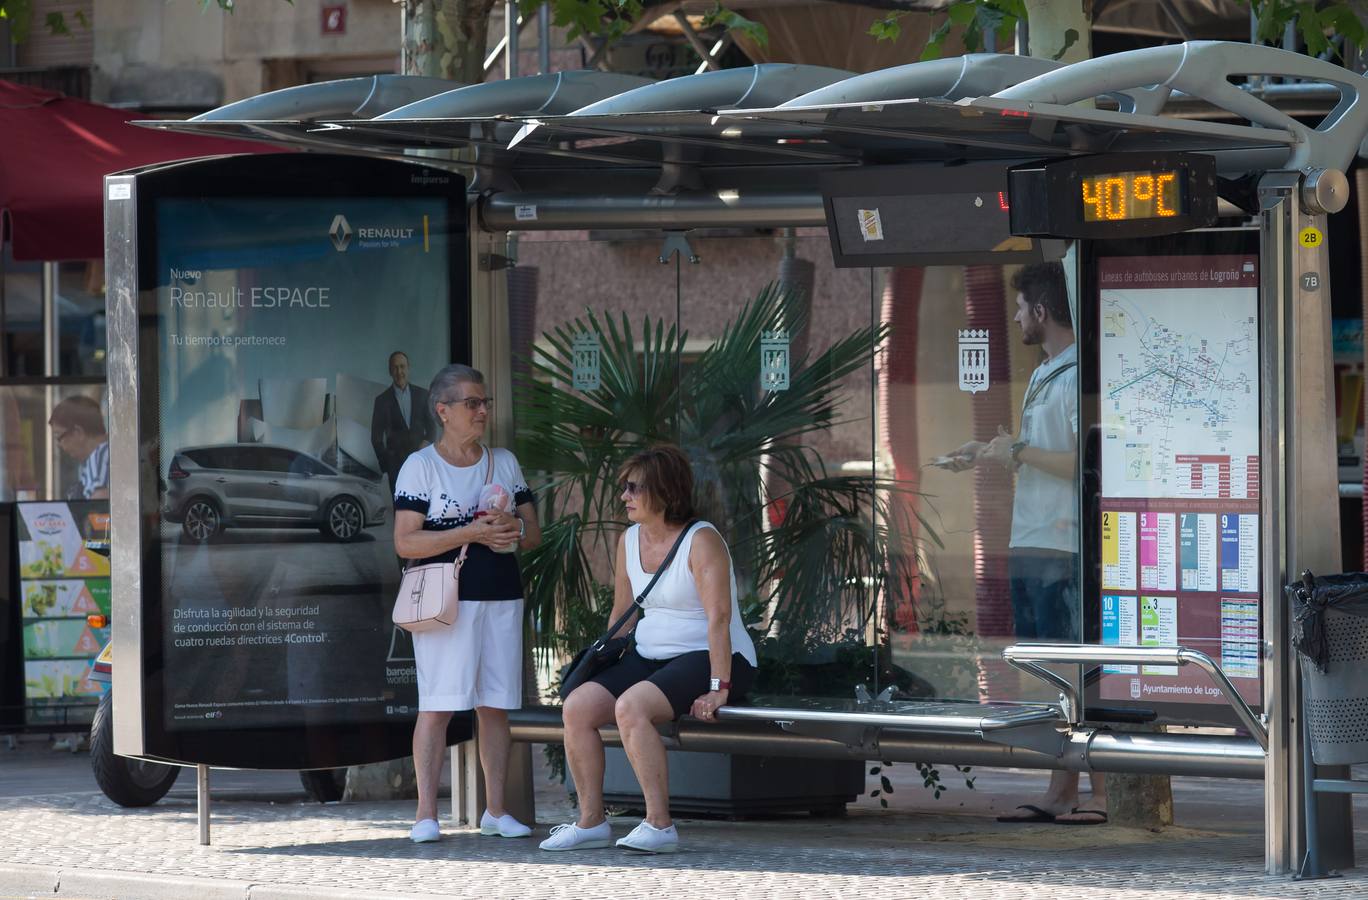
[{"x1": 142, "y1": 41, "x2": 1368, "y2": 193}]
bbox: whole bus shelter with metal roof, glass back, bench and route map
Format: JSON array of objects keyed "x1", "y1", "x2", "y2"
[{"x1": 117, "y1": 42, "x2": 1368, "y2": 873}]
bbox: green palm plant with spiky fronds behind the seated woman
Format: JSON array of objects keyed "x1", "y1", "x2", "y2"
[{"x1": 514, "y1": 284, "x2": 938, "y2": 672}]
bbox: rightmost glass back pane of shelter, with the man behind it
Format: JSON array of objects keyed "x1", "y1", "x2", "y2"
[{"x1": 877, "y1": 255, "x2": 1081, "y2": 700}]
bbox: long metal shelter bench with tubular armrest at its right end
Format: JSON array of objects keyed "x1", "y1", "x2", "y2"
[{"x1": 481, "y1": 644, "x2": 1268, "y2": 826}]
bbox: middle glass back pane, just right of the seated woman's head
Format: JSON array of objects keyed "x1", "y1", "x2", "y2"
[{"x1": 674, "y1": 230, "x2": 885, "y2": 700}]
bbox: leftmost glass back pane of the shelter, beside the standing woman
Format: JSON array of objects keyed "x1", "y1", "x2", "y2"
[{"x1": 508, "y1": 231, "x2": 684, "y2": 699}]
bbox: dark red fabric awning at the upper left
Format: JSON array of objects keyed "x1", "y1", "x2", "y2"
[{"x1": 0, "y1": 81, "x2": 279, "y2": 261}]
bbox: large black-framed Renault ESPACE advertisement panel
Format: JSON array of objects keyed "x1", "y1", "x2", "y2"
[{"x1": 115, "y1": 155, "x2": 468, "y2": 767}]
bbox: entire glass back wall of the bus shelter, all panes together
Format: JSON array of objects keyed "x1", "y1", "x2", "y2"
[{"x1": 509, "y1": 230, "x2": 1081, "y2": 700}]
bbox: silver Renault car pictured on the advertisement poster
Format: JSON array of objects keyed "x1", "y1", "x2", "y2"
[{"x1": 161, "y1": 443, "x2": 390, "y2": 543}]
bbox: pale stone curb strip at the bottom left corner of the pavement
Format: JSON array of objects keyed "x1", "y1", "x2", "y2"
[{"x1": 0, "y1": 863, "x2": 440, "y2": 900}]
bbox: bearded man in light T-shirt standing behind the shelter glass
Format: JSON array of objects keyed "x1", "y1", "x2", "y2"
[{"x1": 951, "y1": 263, "x2": 1107, "y2": 825}]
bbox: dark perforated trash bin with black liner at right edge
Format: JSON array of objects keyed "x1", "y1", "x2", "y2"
[{"x1": 1285, "y1": 572, "x2": 1368, "y2": 766}]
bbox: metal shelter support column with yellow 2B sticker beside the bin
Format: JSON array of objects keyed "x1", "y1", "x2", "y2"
[{"x1": 1260, "y1": 172, "x2": 1353, "y2": 874}]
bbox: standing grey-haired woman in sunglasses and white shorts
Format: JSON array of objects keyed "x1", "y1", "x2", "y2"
[{"x1": 394, "y1": 365, "x2": 542, "y2": 843}]
